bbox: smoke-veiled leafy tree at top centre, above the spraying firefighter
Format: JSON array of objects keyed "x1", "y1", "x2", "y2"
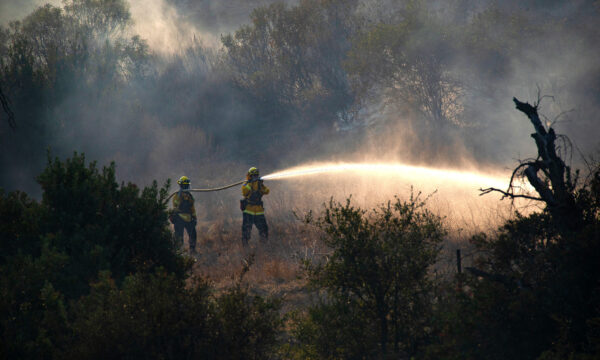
[{"x1": 222, "y1": 0, "x2": 357, "y2": 126}]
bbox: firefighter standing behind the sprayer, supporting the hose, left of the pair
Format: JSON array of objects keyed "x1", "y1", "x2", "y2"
[{"x1": 169, "y1": 176, "x2": 197, "y2": 254}]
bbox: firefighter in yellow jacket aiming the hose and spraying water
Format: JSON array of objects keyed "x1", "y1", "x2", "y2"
[{"x1": 240, "y1": 167, "x2": 269, "y2": 246}]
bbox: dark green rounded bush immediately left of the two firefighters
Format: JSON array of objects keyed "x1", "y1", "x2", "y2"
[{"x1": 38, "y1": 154, "x2": 187, "y2": 297}]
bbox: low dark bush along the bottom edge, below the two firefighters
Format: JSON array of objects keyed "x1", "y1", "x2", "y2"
[{"x1": 64, "y1": 270, "x2": 281, "y2": 359}]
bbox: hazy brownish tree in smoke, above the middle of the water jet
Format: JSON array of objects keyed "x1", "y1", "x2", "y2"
[{"x1": 345, "y1": 1, "x2": 463, "y2": 127}]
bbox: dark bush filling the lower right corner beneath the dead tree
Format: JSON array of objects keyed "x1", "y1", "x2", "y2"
[{"x1": 428, "y1": 171, "x2": 600, "y2": 359}]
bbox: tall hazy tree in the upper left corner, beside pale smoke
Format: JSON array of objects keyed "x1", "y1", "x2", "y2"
[{"x1": 0, "y1": 0, "x2": 149, "y2": 190}]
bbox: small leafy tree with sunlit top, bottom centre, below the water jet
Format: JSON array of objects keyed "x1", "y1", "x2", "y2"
[{"x1": 297, "y1": 196, "x2": 445, "y2": 358}]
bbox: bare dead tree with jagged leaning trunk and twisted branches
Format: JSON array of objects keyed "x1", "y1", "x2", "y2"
[{"x1": 480, "y1": 98, "x2": 582, "y2": 231}]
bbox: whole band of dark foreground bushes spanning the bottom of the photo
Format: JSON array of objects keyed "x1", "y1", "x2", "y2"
[{"x1": 0, "y1": 154, "x2": 600, "y2": 359}]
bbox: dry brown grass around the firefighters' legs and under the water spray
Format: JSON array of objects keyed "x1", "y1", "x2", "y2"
[{"x1": 172, "y1": 184, "x2": 524, "y2": 309}]
